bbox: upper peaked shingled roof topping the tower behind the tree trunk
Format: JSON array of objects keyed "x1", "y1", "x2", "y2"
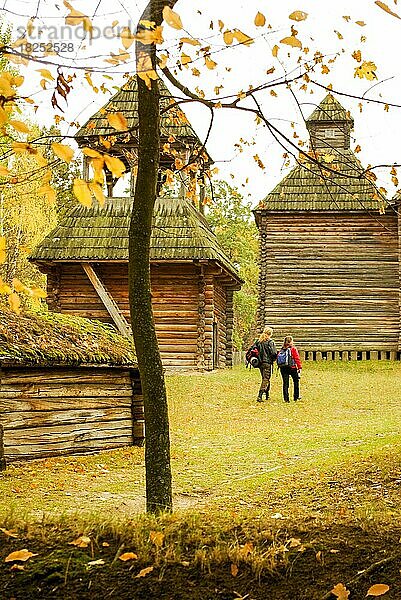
[{"x1": 74, "y1": 77, "x2": 208, "y2": 156}]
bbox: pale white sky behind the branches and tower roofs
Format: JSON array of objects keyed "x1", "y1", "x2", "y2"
[{"x1": 0, "y1": 0, "x2": 401, "y2": 204}]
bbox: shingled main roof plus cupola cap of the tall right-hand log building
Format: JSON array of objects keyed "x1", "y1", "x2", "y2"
[{"x1": 255, "y1": 94, "x2": 382, "y2": 215}]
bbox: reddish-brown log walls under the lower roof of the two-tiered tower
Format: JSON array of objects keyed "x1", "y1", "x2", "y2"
[{"x1": 48, "y1": 263, "x2": 232, "y2": 370}]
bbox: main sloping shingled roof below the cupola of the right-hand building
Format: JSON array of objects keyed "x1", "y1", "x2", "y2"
[{"x1": 256, "y1": 149, "x2": 380, "y2": 211}]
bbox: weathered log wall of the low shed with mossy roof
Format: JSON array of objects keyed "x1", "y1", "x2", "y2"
[{"x1": 0, "y1": 367, "x2": 143, "y2": 461}]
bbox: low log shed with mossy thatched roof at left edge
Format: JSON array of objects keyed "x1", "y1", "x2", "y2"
[{"x1": 0, "y1": 306, "x2": 144, "y2": 467}]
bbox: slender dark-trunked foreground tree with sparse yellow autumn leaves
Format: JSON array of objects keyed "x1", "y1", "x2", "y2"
[{"x1": 0, "y1": 0, "x2": 399, "y2": 512}]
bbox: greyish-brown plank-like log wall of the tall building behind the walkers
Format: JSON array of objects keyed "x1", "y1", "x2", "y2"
[{"x1": 258, "y1": 211, "x2": 400, "y2": 352}]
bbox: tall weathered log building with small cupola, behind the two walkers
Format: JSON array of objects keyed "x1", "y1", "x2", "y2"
[{"x1": 254, "y1": 94, "x2": 401, "y2": 360}]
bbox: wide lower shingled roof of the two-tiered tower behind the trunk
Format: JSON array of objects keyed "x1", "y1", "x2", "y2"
[{"x1": 30, "y1": 198, "x2": 239, "y2": 281}]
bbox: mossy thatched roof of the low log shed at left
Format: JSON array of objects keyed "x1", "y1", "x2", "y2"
[{"x1": 0, "y1": 305, "x2": 136, "y2": 366}]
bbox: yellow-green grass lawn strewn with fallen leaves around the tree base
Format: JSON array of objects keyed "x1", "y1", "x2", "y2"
[{"x1": 0, "y1": 361, "x2": 401, "y2": 600}]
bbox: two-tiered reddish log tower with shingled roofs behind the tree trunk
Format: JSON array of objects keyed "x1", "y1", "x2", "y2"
[{"x1": 31, "y1": 78, "x2": 241, "y2": 370}]
